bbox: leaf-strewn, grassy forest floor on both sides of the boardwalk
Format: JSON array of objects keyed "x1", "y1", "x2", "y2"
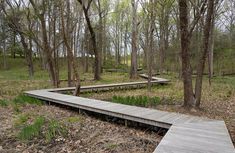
[{"x1": 0, "y1": 69, "x2": 235, "y2": 153}]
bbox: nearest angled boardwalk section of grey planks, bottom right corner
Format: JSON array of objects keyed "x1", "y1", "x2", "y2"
[{"x1": 154, "y1": 121, "x2": 234, "y2": 153}]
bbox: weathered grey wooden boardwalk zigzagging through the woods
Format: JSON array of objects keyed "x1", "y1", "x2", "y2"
[{"x1": 25, "y1": 82, "x2": 235, "y2": 153}]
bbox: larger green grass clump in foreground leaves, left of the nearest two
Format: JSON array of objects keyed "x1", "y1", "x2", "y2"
[{"x1": 18, "y1": 116, "x2": 45, "y2": 141}]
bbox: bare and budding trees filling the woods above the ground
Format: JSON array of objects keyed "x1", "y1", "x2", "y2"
[{"x1": 0, "y1": 0, "x2": 235, "y2": 106}]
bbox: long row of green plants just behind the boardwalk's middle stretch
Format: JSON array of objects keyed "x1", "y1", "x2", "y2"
[{"x1": 112, "y1": 95, "x2": 161, "y2": 107}]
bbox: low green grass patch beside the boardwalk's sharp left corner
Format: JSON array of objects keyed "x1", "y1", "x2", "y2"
[{"x1": 12, "y1": 94, "x2": 43, "y2": 105}]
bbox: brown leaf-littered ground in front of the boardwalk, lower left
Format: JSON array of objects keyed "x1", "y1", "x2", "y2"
[{"x1": 0, "y1": 105, "x2": 161, "y2": 153}]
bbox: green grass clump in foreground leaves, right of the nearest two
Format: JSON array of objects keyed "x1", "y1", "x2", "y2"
[{"x1": 45, "y1": 120, "x2": 67, "y2": 142}]
